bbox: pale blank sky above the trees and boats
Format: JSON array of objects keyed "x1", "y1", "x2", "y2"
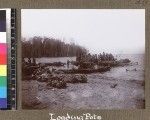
[{"x1": 21, "y1": 9, "x2": 145, "y2": 54}]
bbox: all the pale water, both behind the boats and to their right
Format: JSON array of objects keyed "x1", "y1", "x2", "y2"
[{"x1": 36, "y1": 54, "x2": 144, "y2": 80}]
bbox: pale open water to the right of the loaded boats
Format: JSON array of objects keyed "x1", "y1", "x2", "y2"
[{"x1": 103, "y1": 55, "x2": 144, "y2": 80}]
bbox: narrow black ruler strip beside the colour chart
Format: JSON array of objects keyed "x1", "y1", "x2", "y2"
[{"x1": 7, "y1": 9, "x2": 17, "y2": 109}]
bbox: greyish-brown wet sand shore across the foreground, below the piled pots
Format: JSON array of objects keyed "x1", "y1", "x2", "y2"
[{"x1": 22, "y1": 71, "x2": 144, "y2": 109}]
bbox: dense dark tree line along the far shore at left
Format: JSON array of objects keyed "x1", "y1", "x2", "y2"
[{"x1": 22, "y1": 36, "x2": 88, "y2": 58}]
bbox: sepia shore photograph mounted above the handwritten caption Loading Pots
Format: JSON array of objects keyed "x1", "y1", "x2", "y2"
[{"x1": 21, "y1": 9, "x2": 145, "y2": 110}]
